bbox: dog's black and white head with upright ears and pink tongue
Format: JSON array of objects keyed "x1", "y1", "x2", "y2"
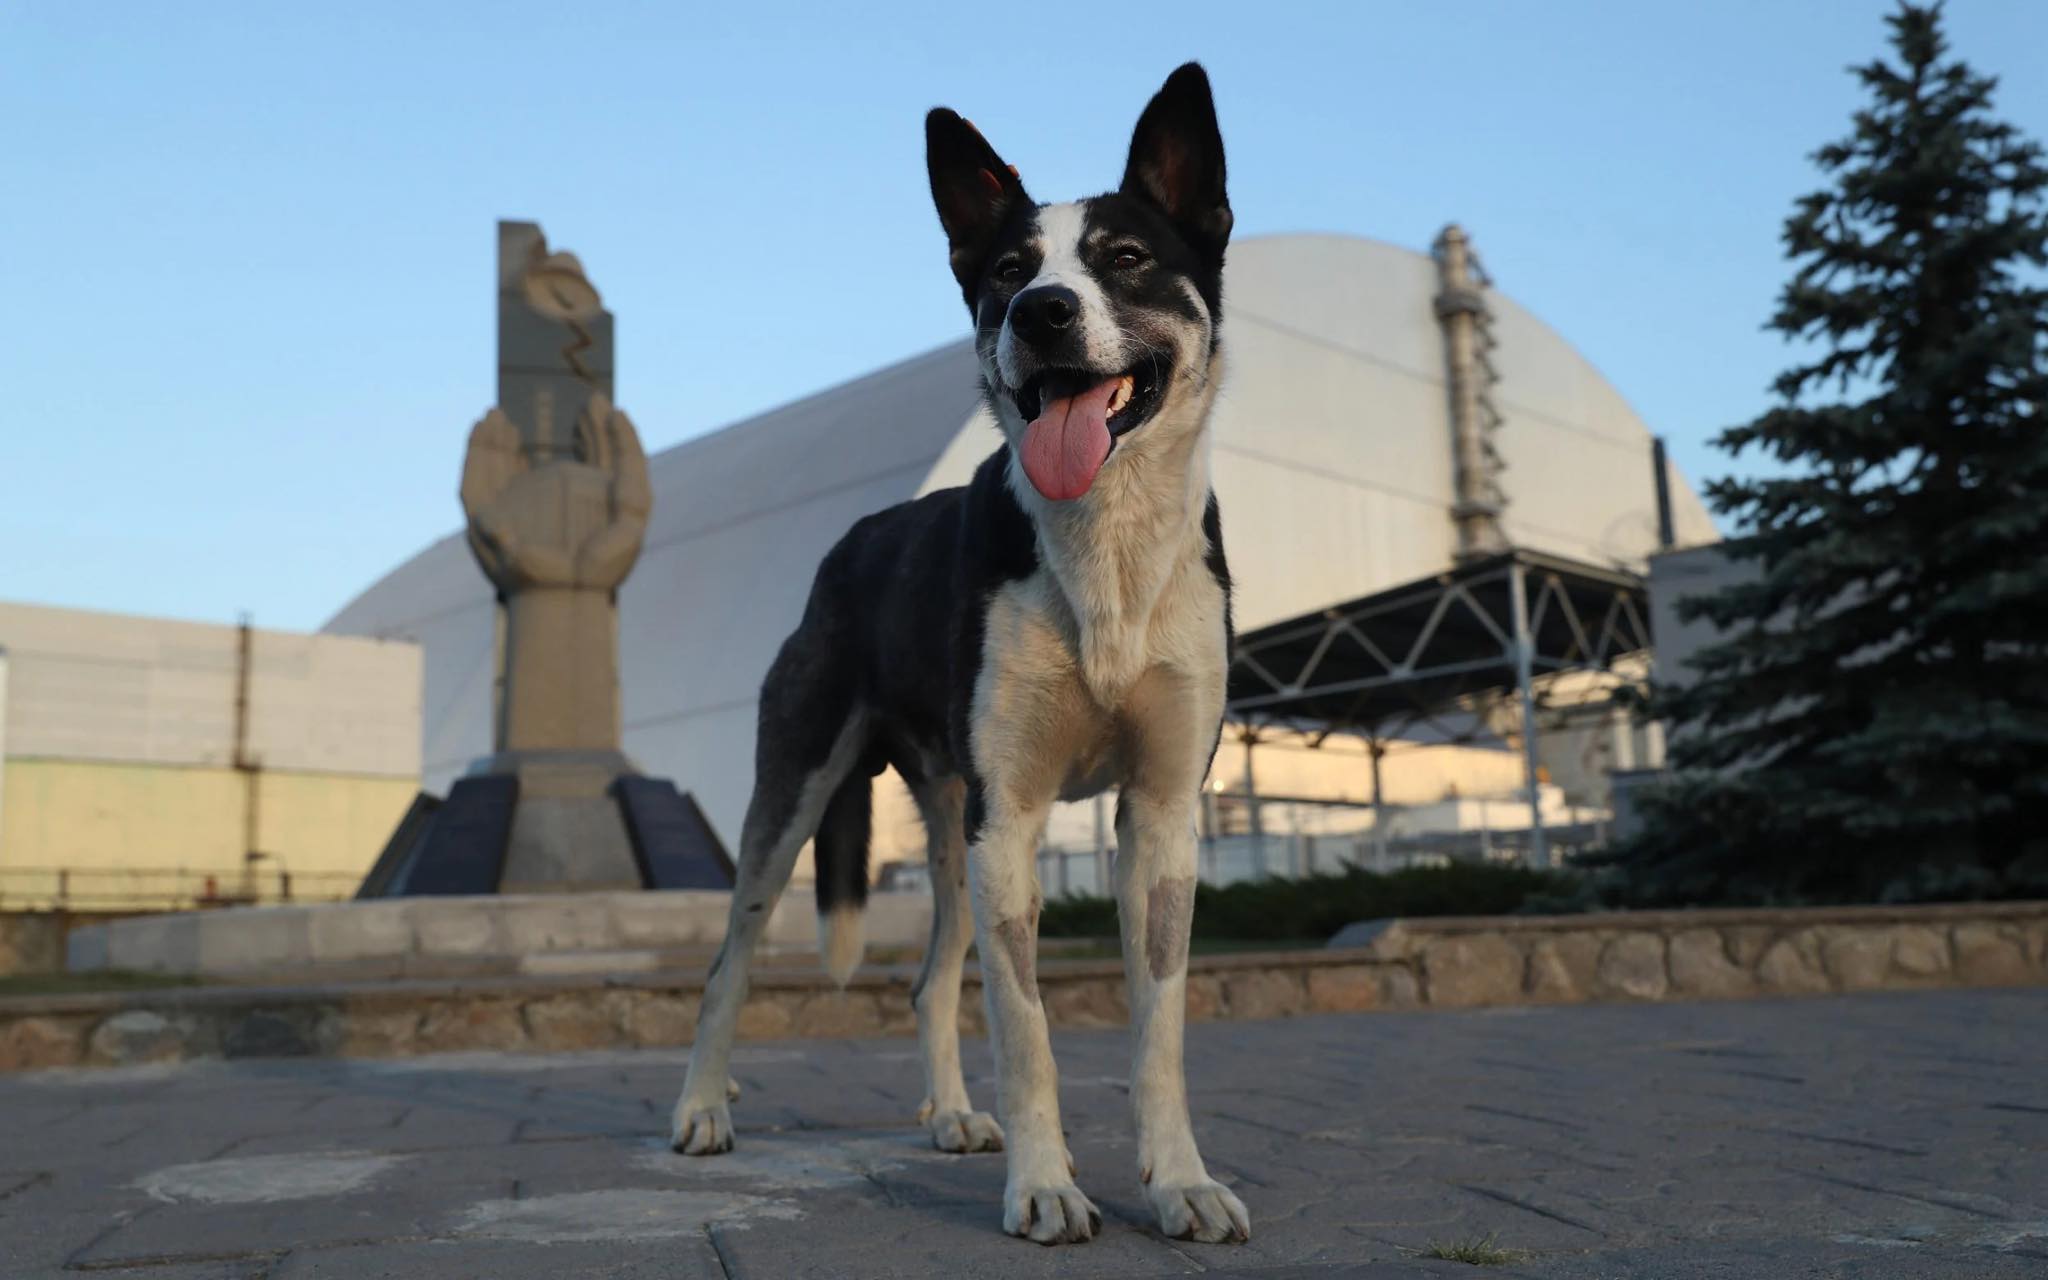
[{"x1": 924, "y1": 61, "x2": 1231, "y2": 502}]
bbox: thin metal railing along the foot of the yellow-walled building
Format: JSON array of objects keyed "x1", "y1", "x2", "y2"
[{"x1": 0, "y1": 866, "x2": 362, "y2": 911}]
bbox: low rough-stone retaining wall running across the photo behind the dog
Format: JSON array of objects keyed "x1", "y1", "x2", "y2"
[{"x1": 0, "y1": 903, "x2": 2048, "y2": 1069}]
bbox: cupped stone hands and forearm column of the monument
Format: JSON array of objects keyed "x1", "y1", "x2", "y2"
[{"x1": 463, "y1": 393, "x2": 653, "y2": 752}]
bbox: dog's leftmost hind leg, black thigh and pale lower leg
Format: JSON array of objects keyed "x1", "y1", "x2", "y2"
[{"x1": 670, "y1": 633, "x2": 864, "y2": 1155}]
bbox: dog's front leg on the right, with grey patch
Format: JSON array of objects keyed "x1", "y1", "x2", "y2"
[{"x1": 1114, "y1": 672, "x2": 1251, "y2": 1243}]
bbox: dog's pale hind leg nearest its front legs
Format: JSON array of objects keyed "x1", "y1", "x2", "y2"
[{"x1": 909, "y1": 778, "x2": 1004, "y2": 1151}]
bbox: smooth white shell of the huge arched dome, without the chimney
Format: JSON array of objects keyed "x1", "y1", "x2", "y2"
[{"x1": 326, "y1": 236, "x2": 1718, "y2": 846}]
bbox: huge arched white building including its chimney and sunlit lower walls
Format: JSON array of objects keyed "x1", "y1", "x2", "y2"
[{"x1": 326, "y1": 236, "x2": 1716, "y2": 884}]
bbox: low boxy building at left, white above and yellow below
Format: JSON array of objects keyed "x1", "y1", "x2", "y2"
[{"x1": 0, "y1": 604, "x2": 422, "y2": 911}]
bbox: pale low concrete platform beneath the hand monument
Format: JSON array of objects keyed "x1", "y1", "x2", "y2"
[{"x1": 68, "y1": 889, "x2": 932, "y2": 983}]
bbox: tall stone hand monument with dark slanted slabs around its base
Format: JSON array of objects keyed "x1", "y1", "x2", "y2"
[{"x1": 358, "y1": 221, "x2": 731, "y2": 897}]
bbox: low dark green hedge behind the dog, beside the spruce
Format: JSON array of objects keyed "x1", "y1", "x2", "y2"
[{"x1": 1038, "y1": 862, "x2": 1581, "y2": 942}]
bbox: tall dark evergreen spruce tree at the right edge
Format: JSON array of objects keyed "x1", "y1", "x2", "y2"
[{"x1": 1606, "y1": 4, "x2": 2048, "y2": 901}]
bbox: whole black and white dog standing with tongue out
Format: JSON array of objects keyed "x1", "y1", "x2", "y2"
[{"x1": 672, "y1": 63, "x2": 1249, "y2": 1243}]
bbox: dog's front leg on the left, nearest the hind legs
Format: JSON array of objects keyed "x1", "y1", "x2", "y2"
[{"x1": 969, "y1": 786, "x2": 1102, "y2": 1245}]
